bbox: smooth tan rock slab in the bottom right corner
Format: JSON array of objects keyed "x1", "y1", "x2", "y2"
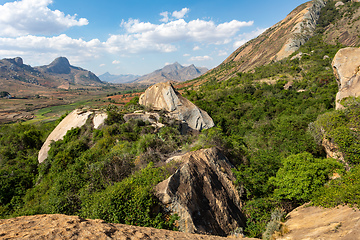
[{"x1": 276, "y1": 205, "x2": 360, "y2": 240}]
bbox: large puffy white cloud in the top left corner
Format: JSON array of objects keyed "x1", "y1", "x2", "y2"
[{"x1": 0, "y1": 0, "x2": 89, "y2": 37}]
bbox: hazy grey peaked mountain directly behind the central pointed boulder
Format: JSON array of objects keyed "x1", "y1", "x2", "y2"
[{"x1": 134, "y1": 62, "x2": 208, "y2": 85}]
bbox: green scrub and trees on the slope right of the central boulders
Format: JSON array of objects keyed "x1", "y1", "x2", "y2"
[{"x1": 185, "y1": 32, "x2": 350, "y2": 237}]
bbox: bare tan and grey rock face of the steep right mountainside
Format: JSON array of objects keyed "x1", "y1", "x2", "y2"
[{"x1": 201, "y1": 0, "x2": 325, "y2": 79}]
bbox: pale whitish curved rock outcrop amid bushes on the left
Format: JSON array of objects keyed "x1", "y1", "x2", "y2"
[{"x1": 38, "y1": 109, "x2": 107, "y2": 163}]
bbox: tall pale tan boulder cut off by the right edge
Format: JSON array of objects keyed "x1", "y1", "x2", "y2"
[{"x1": 332, "y1": 47, "x2": 360, "y2": 109}]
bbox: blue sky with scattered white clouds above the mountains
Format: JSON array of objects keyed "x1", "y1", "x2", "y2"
[{"x1": 0, "y1": 0, "x2": 306, "y2": 75}]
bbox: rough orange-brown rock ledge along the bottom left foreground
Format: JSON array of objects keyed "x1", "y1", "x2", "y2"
[{"x1": 0, "y1": 214, "x2": 258, "y2": 240}]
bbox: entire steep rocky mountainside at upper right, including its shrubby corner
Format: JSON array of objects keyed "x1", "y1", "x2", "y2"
[{"x1": 191, "y1": 0, "x2": 360, "y2": 82}]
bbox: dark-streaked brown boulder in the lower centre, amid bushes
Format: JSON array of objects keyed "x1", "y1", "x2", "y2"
[{"x1": 155, "y1": 148, "x2": 245, "y2": 236}]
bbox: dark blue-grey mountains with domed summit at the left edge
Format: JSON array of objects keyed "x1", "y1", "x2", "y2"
[{"x1": 0, "y1": 57, "x2": 104, "y2": 95}]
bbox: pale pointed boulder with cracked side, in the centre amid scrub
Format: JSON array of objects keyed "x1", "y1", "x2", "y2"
[{"x1": 139, "y1": 82, "x2": 215, "y2": 131}]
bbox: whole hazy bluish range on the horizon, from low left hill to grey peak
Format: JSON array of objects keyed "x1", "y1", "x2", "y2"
[{"x1": 99, "y1": 62, "x2": 208, "y2": 85}]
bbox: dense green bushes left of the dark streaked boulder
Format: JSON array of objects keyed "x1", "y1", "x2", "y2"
[{"x1": 0, "y1": 102, "x2": 191, "y2": 229}]
